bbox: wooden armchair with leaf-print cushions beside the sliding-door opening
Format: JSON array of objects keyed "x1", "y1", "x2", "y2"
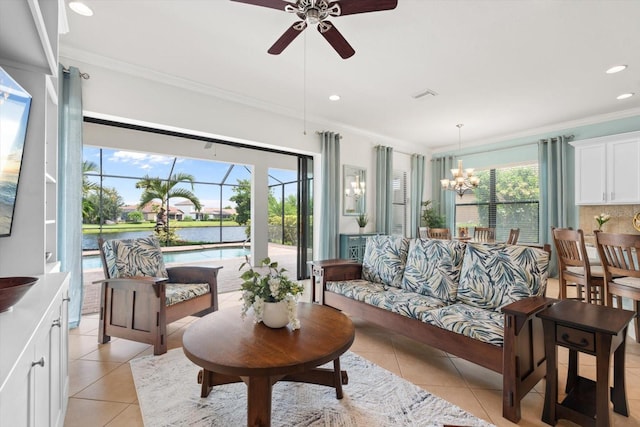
[{"x1": 96, "y1": 236, "x2": 222, "y2": 355}]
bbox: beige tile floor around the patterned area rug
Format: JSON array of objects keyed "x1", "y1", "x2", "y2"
[{"x1": 64, "y1": 280, "x2": 640, "y2": 427}]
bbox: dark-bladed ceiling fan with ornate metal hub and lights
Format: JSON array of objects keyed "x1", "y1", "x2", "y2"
[{"x1": 231, "y1": 0, "x2": 398, "y2": 59}]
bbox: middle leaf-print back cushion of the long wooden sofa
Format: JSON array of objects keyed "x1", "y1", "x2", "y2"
[{"x1": 401, "y1": 239, "x2": 465, "y2": 302}]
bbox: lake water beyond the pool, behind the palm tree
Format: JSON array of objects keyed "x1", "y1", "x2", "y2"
[{"x1": 82, "y1": 226, "x2": 247, "y2": 250}]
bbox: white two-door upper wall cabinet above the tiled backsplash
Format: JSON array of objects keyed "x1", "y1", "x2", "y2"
[{"x1": 571, "y1": 132, "x2": 640, "y2": 205}]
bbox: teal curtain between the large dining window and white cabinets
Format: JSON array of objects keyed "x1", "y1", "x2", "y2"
[{"x1": 538, "y1": 136, "x2": 577, "y2": 276}]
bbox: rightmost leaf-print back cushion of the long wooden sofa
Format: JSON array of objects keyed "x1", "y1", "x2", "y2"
[{"x1": 458, "y1": 243, "x2": 549, "y2": 310}]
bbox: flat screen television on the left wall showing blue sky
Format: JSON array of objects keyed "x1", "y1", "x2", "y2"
[{"x1": 0, "y1": 67, "x2": 31, "y2": 237}]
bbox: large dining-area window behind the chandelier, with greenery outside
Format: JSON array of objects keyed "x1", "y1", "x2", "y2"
[{"x1": 455, "y1": 163, "x2": 540, "y2": 243}]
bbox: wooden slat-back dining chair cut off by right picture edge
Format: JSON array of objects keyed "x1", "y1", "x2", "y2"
[{"x1": 594, "y1": 230, "x2": 640, "y2": 343}]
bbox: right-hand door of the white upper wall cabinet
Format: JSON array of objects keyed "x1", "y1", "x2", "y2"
[{"x1": 608, "y1": 138, "x2": 640, "y2": 204}]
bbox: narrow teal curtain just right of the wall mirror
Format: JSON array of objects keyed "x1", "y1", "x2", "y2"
[{"x1": 375, "y1": 145, "x2": 393, "y2": 234}]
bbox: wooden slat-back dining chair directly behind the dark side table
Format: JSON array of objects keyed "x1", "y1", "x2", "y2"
[{"x1": 551, "y1": 227, "x2": 606, "y2": 305}]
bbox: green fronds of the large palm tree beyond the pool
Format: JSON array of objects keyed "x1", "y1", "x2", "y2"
[{"x1": 136, "y1": 173, "x2": 202, "y2": 229}]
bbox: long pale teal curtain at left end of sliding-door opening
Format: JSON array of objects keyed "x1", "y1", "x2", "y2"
[{"x1": 57, "y1": 65, "x2": 84, "y2": 328}]
